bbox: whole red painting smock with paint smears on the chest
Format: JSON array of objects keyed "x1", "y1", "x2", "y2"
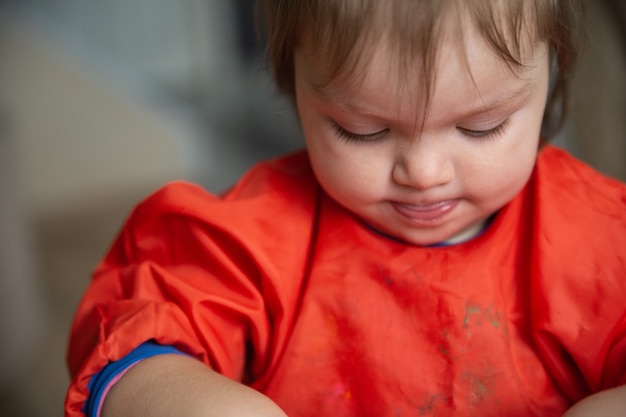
[{"x1": 66, "y1": 147, "x2": 626, "y2": 417}]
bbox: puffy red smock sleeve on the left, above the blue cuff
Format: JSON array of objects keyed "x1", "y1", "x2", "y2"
[{"x1": 65, "y1": 153, "x2": 317, "y2": 416}]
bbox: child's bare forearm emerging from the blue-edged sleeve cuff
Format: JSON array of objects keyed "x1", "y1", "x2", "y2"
[{"x1": 102, "y1": 354, "x2": 285, "y2": 417}]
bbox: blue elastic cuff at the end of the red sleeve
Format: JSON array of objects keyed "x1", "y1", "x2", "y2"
[{"x1": 83, "y1": 341, "x2": 185, "y2": 417}]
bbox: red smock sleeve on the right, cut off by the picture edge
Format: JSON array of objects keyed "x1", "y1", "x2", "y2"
[{"x1": 528, "y1": 147, "x2": 626, "y2": 402}]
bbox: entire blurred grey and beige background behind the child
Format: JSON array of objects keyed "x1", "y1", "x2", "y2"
[{"x1": 0, "y1": 0, "x2": 626, "y2": 417}]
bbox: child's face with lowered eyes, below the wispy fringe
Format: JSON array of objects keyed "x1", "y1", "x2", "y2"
[{"x1": 295, "y1": 22, "x2": 549, "y2": 245}]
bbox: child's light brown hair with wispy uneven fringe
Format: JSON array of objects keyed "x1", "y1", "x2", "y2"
[{"x1": 258, "y1": 0, "x2": 583, "y2": 140}]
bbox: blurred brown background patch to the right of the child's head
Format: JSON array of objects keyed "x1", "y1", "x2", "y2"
[{"x1": 564, "y1": 0, "x2": 626, "y2": 181}]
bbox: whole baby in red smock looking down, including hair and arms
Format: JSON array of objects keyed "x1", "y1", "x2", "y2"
[{"x1": 65, "y1": 0, "x2": 626, "y2": 417}]
